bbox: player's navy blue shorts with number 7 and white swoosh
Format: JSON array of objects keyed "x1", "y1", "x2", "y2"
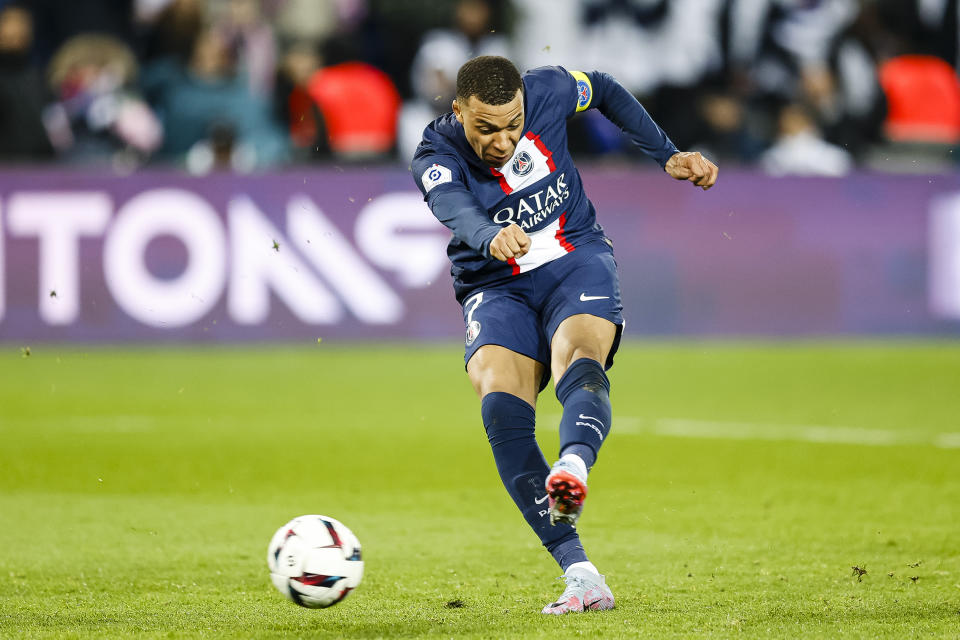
[{"x1": 463, "y1": 241, "x2": 623, "y2": 390}]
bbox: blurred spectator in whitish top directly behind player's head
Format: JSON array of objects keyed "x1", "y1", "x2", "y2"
[{"x1": 397, "y1": 0, "x2": 510, "y2": 161}]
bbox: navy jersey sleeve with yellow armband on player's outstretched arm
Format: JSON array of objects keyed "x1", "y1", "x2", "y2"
[{"x1": 530, "y1": 67, "x2": 677, "y2": 167}]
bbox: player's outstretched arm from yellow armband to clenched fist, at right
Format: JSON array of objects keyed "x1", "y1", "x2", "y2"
[{"x1": 569, "y1": 71, "x2": 719, "y2": 190}]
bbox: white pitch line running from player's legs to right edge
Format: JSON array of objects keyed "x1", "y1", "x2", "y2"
[{"x1": 543, "y1": 414, "x2": 960, "y2": 449}]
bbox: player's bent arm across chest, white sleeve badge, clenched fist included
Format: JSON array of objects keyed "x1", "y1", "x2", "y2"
[{"x1": 411, "y1": 147, "x2": 530, "y2": 262}]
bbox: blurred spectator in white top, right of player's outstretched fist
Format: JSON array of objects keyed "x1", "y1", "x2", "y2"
[{"x1": 760, "y1": 104, "x2": 853, "y2": 177}]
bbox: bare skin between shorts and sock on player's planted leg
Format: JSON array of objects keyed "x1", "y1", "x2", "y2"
[{"x1": 467, "y1": 344, "x2": 547, "y2": 407}]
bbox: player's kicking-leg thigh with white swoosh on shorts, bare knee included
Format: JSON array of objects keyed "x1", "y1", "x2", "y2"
[{"x1": 543, "y1": 246, "x2": 623, "y2": 380}]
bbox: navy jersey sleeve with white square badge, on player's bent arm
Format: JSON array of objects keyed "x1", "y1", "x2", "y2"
[{"x1": 410, "y1": 145, "x2": 502, "y2": 258}]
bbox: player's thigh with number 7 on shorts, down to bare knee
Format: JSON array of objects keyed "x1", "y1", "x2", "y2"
[{"x1": 463, "y1": 287, "x2": 550, "y2": 404}]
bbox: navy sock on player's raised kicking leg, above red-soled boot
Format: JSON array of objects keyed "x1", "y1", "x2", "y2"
[{"x1": 556, "y1": 358, "x2": 611, "y2": 469}]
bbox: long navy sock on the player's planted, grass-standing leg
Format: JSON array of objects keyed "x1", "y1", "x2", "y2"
[{"x1": 480, "y1": 391, "x2": 587, "y2": 571}]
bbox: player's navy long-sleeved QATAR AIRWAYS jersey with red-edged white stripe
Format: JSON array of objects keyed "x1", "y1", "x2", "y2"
[{"x1": 411, "y1": 67, "x2": 677, "y2": 302}]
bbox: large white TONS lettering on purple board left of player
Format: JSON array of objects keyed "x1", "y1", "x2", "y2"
[{"x1": 0, "y1": 188, "x2": 449, "y2": 329}]
